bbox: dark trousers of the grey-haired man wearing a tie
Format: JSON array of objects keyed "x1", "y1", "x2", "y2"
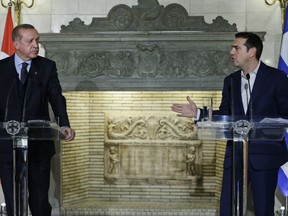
[{"x1": 0, "y1": 160, "x2": 52, "y2": 216}]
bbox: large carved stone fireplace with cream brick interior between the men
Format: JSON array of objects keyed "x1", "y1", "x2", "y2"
[{"x1": 40, "y1": 0, "x2": 265, "y2": 216}]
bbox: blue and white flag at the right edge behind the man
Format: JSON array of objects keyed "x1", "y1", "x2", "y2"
[{"x1": 278, "y1": 5, "x2": 288, "y2": 197}]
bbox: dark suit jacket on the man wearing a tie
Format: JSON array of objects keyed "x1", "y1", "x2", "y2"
[{"x1": 0, "y1": 55, "x2": 70, "y2": 162}]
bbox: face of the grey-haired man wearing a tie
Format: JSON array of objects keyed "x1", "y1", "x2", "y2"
[{"x1": 14, "y1": 29, "x2": 39, "y2": 61}]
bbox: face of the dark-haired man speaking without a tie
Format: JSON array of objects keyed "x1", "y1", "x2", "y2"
[{"x1": 230, "y1": 38, "x2": 250, "y2": 68}]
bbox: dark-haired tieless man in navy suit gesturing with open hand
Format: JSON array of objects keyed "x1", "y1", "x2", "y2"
[{"x1": 172, "y1": 32, "x2": 288, "y2": 216}]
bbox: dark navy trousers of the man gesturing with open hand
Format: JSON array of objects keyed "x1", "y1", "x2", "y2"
[{"x1": 220, "y1": 157, "x2": 278, "y2": 216}]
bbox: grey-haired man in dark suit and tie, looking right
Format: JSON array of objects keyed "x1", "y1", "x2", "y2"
[{"x1": 0, "y1": 24, "x2": 75, "y2": 216}]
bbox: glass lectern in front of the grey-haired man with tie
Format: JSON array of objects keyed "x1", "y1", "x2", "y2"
[{"x1": 0, "y1": 120, "x2": 60, "y2": 216}]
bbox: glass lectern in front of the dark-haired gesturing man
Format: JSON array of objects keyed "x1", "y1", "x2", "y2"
[{"x1": 197, "y1": 116, "x2": 288, "y2": 216}]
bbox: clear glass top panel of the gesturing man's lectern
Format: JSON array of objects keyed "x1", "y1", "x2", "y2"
[{"x1": 197, "y1": 116, "x2": 288, "y2": 141}]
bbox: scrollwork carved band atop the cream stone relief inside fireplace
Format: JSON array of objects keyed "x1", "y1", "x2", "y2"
[{"x1": 107, "y1": 116, "x2": 196, "y2": 140}]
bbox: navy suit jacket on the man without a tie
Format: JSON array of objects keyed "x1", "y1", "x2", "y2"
[{"x1": 218, "y1": 62, "x2": 288, "y2": 170}]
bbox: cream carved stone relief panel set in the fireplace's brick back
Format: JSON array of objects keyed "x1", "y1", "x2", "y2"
[{"x1": 105, "y1": 115, "x2": 202, "y2": 184}]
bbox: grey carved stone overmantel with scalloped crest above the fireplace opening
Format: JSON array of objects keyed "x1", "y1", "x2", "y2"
[{"x1": 41, "y1": 0, "x2": 265, "y2": 91}]
